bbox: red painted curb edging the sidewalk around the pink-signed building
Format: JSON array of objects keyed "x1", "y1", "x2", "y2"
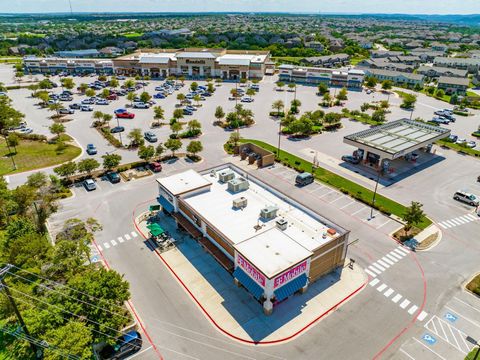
[{"x1": 133, "y1": 203, "x2": 368, "y2": 345}]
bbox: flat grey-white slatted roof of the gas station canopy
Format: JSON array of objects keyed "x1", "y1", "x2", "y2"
[{"x1": 344, "y1": 119, "x2": 450, "y2": 159}]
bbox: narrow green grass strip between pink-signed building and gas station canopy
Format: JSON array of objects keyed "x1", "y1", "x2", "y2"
[{"x1": 235, "y1": 139, "x2": 432, "y2": 230}]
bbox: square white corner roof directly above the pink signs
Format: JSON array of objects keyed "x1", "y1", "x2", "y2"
[{"x1": 235, "y1": 228, "x2": 312, "y2": 279}]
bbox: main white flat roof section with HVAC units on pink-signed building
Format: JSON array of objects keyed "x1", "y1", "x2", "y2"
[{"x1": 183, "y1": 167, "x2": 337, "y2": 250}]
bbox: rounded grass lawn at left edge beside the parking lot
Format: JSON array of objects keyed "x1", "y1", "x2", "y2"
[{"x1": 0, "y1": 139, "x2": 82, "y2": 176}]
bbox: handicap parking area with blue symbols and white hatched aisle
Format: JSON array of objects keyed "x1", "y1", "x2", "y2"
[{"x1": 400, "y1": 292, "x2": 480, "y2": 360}]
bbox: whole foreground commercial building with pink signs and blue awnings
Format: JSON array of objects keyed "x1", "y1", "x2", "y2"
[{"x1": 157, "y1": 164, "x2": 349, "y2": 314}]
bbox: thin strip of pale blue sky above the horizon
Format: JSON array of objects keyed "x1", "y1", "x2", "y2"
[{"x1": 0, "y1": 0, "x2": 480, "y2": 14}]
